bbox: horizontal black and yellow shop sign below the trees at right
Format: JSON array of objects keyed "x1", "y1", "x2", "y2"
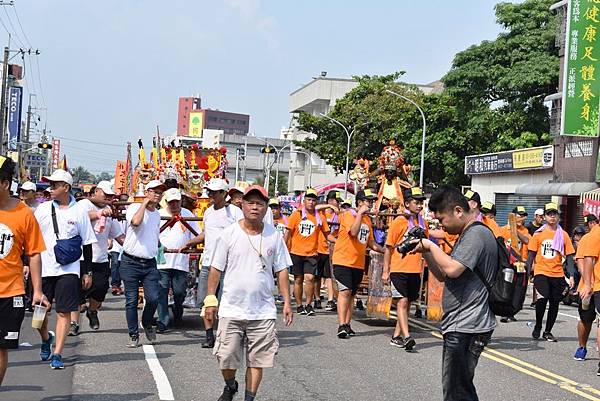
[{"x1": 465, "y1": 146, "x2": 554, "y2": 175}]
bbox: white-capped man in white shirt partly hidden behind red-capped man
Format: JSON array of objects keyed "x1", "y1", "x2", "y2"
[{"x1": 186, "y1": 178, "x2": 244, "y2": 348}]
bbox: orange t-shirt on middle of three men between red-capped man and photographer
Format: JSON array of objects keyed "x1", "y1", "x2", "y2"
[{"x1": 331, "y1": 211, "x2": 373, "y2": 270}]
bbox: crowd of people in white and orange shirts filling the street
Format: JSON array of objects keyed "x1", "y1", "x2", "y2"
[{"x1": 0, "y1": 156, "x2": 600, "y2": 401}]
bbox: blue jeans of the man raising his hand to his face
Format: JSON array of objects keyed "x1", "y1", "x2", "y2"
[{"x1": 119, "y1": 254, "x2": 160, "y2": 335}]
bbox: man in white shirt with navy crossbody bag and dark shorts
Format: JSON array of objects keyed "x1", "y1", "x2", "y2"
[{"x1": 35, "y1": 169, "x2": 96, "y2": 369}]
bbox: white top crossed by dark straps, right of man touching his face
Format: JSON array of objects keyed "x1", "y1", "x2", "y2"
[{"x1": 157, "y1": 208, "x2": 202, "y2": 272}]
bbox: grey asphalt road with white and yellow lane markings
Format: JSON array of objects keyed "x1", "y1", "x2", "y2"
[{"x1": 0, "y1": 295, "x2": 600, "y2": 401}]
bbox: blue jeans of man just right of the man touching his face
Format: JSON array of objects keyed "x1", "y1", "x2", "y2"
[{"x1": 158, "y1": 269, "x2": 188, "y2": 327}]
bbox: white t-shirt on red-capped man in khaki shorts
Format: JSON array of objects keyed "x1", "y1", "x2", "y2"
[{"x1": 211, "y1": 223, "x2": 292, "y2": 320}]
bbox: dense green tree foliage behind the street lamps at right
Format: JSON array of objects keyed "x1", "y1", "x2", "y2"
[{"x1": 297, "y1": 0, "x2": 559, "y2": 185}]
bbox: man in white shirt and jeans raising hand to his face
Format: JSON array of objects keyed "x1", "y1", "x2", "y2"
[{"x1": 119, "y1": 180, "x2": 166, "y2": 348}]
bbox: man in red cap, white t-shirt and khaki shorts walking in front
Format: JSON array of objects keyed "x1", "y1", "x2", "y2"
[{"x1": 204, "y1": 185, "x2": 293, "y2": 401}]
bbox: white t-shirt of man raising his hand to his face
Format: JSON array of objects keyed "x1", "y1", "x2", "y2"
[{"x1": 123, "y1": 203, "x2": 160, "y2": 259}]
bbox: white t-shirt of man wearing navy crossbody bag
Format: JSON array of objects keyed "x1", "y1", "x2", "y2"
[{"x1": 35, "y1": 198, "x2": 96, "y2": 277}]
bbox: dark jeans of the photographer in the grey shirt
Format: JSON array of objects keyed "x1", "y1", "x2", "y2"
[{"x1": 442, "y1": 331, "x2": 492, "y2": 401}]
